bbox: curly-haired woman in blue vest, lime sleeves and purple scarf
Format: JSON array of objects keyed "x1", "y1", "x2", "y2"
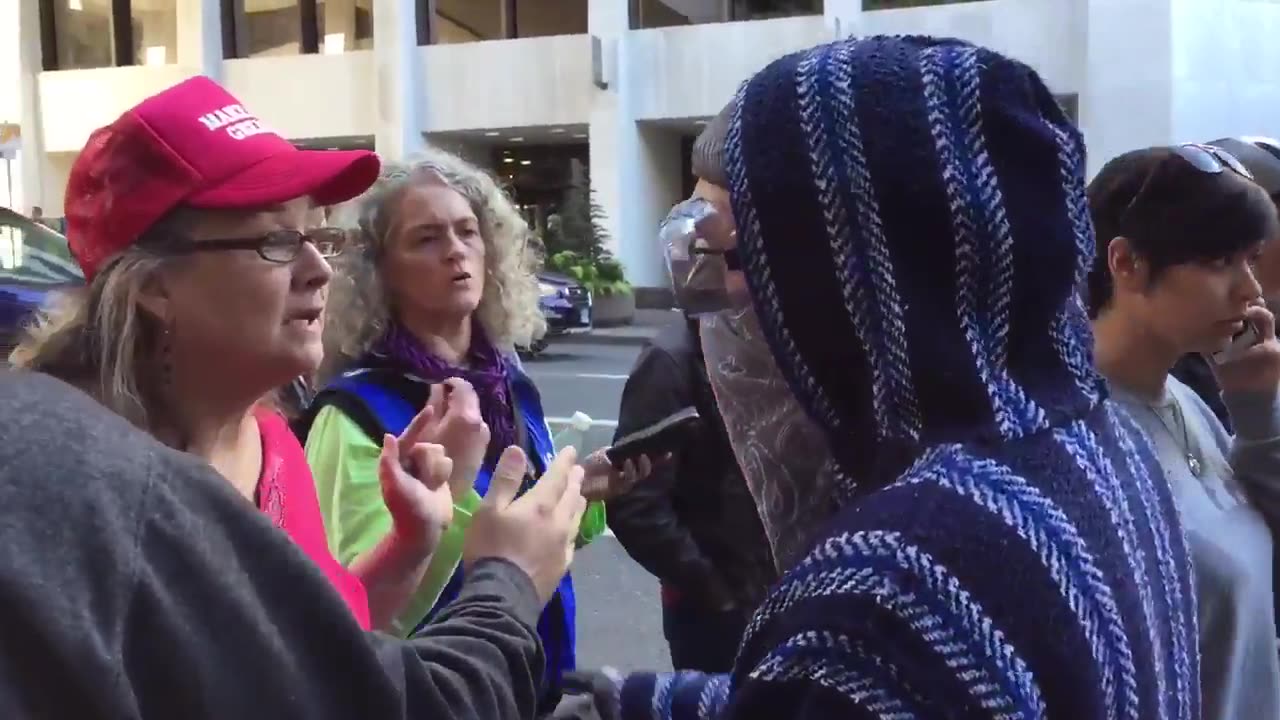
[{"x1": 300, "y1": 150, "x2": 649, "y2": 711}]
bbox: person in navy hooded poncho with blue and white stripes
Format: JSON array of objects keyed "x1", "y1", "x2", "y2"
[{"x1": 588, "y1": 32, "x2": 1199, "y2": 720}]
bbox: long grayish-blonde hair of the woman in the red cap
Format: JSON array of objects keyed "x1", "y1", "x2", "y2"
[{"x1": 9, "y1": 246, "x2": 165, "y2": 430}]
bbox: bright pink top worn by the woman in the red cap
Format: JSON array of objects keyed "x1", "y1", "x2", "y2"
[{"x1": 255, "y1": 409, "x2": 370, "y2": 630}]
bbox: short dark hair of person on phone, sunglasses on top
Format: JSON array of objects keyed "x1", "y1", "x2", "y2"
[{"x1": 1088, "y1": 147, "x2": 1280, "y2": 315}]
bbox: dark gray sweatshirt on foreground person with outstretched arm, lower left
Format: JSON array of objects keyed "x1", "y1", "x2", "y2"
[{"x1": 0, "y1": 369, "x2": 544, "y2": 720}]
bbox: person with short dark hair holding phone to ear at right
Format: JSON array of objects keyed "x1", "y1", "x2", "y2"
[{"x1": 1088, "y1": 145, "x2": 1280, "y2": 720}]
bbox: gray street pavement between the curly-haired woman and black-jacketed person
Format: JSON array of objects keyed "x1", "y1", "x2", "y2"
[{"x1": 525, "y1": 338, "x2": 671, "y2": 670}]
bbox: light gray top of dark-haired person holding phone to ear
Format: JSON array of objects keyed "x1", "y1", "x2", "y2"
[{"x1": 1114, "y1": 377, "x2": 1280, "y2": 720}]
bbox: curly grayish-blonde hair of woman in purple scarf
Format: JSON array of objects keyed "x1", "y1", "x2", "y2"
[{"x1": 323, "y1": 142, "x2": 547, "y2": 375}]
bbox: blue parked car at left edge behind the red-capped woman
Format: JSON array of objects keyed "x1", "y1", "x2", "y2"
[{"x1": 0, "y1": 208, "x2": 84, "y2": 361}]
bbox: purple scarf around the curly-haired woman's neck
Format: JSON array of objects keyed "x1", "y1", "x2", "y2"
[{"x1": 375, "y1": 316, "x2": 516, "y2": 464}]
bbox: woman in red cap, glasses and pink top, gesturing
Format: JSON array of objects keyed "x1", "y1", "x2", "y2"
[{"x1": 12, "y1": 77, "x2": 478, "y2": 628}]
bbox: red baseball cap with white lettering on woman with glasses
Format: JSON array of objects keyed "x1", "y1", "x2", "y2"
[{"x1": 64, "y1": 76, "x2": 380, "y2": 278}]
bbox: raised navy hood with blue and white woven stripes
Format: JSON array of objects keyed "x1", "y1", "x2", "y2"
[{"x1": 724, "y1": 37, "x2": 1103, "y2": 486}]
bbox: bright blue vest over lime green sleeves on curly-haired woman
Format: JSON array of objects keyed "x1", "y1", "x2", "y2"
[{"x1": 317, "y1": 361, "x2": 576, "y2": 689}]
